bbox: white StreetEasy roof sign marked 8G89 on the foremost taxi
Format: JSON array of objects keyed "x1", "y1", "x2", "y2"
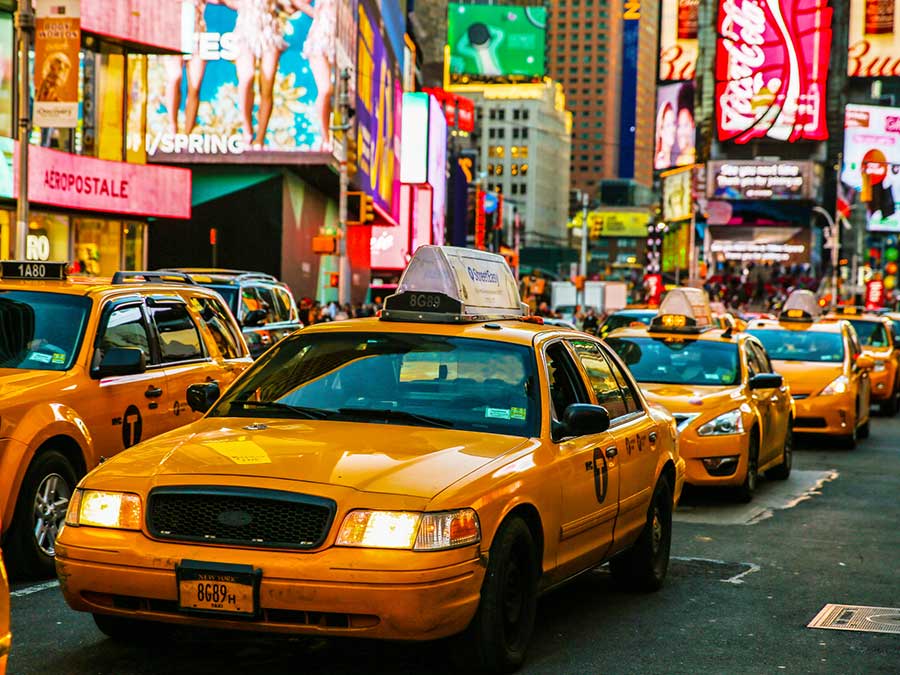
[{"x1": 381, "y1": 246, "x2": 528, "y2": 323}]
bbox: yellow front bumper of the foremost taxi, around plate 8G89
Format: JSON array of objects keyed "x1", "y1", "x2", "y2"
[{"x1": 56, "y1": 527, "x2": 486, "y2": 640}]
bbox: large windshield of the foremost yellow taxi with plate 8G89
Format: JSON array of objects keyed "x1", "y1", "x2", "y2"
[{"x1": 211, "y1": 332, "x2": 540, "y2": 437}]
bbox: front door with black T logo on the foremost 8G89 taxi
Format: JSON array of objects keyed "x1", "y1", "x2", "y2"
[{"x1": 544, "y1": 340, "x2": 619, "y2": 576}]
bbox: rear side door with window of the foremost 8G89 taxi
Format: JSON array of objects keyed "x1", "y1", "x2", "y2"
[{"x1": 571, "y1": 339, "x2": 659, "y2": 546}]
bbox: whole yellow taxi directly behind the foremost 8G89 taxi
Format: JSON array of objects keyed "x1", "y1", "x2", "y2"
[{"x1": 606, "y1": 288, "x2": 794, "y2": 501}]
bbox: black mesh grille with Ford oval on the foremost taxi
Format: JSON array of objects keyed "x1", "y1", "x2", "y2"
[{"x1": 147, "y1": 486, "x2": 336, "y2": 549}]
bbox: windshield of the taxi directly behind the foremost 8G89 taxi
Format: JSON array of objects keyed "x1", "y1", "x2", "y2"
[{"x1": 607, "y1": 337, "x2": 741, "y2": 386}]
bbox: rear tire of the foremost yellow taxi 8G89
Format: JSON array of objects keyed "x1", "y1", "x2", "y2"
[{"x1": 609, "y1": 476, "x2": 672, "y2": 592}]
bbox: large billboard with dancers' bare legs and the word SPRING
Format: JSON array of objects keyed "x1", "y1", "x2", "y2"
[{"x1": 146, "y1": 0, "x2": 336, "y2": 162}]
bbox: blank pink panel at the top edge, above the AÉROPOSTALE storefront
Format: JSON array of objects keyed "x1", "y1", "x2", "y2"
[{"x1": 81, "y1": 0, "x2": 182, "y2": 52}]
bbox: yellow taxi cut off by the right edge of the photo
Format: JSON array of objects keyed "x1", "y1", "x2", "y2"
[{"x1": 822, "y1": 305, "x2": 900, "y2": 416}]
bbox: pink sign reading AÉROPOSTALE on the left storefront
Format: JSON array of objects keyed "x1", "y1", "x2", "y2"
[{"x1": 16, "y1": 146, "x2": 191, "y2": 218}]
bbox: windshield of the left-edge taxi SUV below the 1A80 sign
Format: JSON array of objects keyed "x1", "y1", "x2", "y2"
[{"x1": 0, "y1": 290, "x2": 91, "y2": 370}]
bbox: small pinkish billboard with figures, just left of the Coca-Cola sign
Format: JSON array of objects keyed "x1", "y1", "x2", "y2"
[{"x1": 653, "y1": 82, "x2": 697, "y2": 170}]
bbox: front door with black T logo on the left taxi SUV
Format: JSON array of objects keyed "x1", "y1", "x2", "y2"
[{"x1": 88, "y1": 297, "x2": 172, "y2": 459}]
